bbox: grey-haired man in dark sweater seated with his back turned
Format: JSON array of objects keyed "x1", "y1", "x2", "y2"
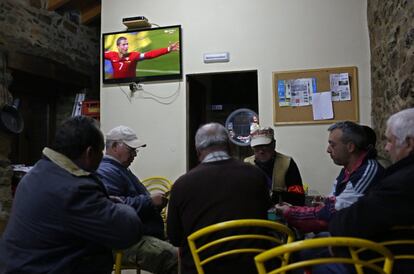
[{"x1": 167, "y1": 123, "x2": 271, "y2": 274}]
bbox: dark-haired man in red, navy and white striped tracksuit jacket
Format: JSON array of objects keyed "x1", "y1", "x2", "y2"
[{"x1": 276, "y1": 121, "x2": 383, "y2": 233}]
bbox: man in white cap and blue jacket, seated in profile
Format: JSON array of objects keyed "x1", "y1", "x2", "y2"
[{"x1": 97, "y1": 126, "x2": 178, "y2": 274}]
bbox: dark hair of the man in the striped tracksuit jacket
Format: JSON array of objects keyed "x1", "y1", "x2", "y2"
[{"x1": 328, "y1": 121, "x2": 367, "y2": 150}]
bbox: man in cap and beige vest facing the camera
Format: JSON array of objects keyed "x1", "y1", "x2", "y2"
[{"x1": 244, "y1": 127, "x2": 305, "y2": 205}]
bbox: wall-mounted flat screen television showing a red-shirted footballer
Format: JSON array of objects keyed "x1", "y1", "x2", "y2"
[{"x1": 102, "y1": 25, "x2": 182, "y2": 84}]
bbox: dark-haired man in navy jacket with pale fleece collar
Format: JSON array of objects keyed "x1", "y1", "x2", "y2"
[{"x1": 0, "y1": 116, "x2": 141, "y2": 274}]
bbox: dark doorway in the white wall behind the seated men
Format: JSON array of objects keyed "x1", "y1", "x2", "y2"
[{"x1": 187, "y1": 70, "x2": 258, "y2": 170}]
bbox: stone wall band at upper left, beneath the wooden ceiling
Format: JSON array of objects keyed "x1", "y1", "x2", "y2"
[{"x1": 0, "y1": 0, "x2": 100, "y2": 75}]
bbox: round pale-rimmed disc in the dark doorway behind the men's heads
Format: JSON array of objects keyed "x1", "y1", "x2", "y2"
[{"x1": 225, "y1": 108, "x2": 259, "y2": 146}]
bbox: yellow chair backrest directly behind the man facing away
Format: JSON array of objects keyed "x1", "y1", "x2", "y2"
[{"x1": 187, "y1": 219, "x2": 295, "y2": 274}]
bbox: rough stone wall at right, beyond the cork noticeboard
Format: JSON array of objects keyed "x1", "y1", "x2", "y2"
[{"x1": 367, "y1": 0, "x2": 414, "y2": 156}]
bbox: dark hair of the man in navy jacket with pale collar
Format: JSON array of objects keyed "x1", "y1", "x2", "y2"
[{"x1": 51, "y1": 116, "x2": 104, "y2": 160}]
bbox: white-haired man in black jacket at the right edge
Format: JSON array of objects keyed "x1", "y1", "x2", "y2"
[{"x1": 329, "y1": 108, "x2": 414, "y2": 273}]
